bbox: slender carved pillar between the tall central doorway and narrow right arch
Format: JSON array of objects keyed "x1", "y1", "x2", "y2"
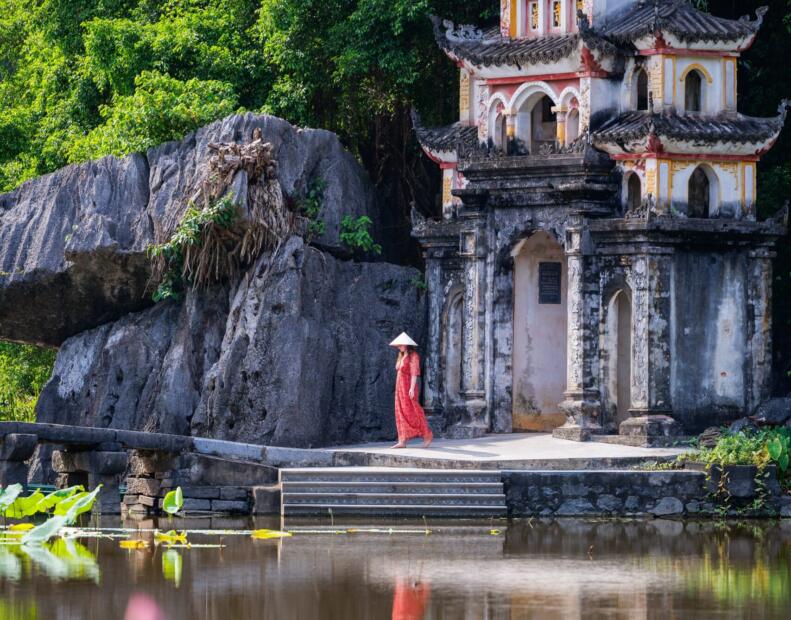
[{"x1": 553, "y1": 216, "x2": 602, "y2": 441}]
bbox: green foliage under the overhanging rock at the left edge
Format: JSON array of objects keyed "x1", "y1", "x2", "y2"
[{"x1": 0, "y1": 341, "x2": 55, "y2": 422}]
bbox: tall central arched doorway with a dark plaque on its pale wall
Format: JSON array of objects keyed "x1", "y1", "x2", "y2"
[{"x1": 512, "y1": 231, "x2": 567, "y2": 432}]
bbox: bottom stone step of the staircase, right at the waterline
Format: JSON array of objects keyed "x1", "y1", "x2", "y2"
[{"x1": 283, "y1": 504, "x2": 507, "y2": 518}]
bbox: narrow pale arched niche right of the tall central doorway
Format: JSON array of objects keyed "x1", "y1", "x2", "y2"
[{"x1": 604, "y1": 290, "x2": 632, "y2": 426}]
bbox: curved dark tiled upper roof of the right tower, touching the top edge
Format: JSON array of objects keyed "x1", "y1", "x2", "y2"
[{"x1": 601, "y1": 0, "x2": 768, "y2": 43}]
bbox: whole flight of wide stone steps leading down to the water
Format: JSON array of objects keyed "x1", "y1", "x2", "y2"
[{"x1": 280, "y1": 467, "x2": 506, "y2": 518}]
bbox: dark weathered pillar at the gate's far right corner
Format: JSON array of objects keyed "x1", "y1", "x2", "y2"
[{"x1": 746, "y1": 248, "x2": 776, "y2": 414}]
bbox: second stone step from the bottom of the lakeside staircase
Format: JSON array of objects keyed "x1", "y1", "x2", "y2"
[{"x1": 283, "y1": 492, "x2": 505, "y2": 506}]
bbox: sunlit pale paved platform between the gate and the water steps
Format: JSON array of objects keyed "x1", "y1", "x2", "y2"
[{"x1": 325, "y1": 433, "x2": 687, "y2": 463}]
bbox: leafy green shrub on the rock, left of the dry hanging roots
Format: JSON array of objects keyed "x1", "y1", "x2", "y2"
[{"x1": 148, "y1": 196, "x2": 239, "y2": 301}]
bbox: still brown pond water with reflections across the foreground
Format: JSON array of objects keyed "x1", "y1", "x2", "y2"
[{"x1": 0, "y1": 519, "x2": 791, "y2": 620}]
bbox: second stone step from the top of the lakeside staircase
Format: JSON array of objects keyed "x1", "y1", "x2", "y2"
[{"x1": 288, "y1": 480, "x2": 503, "y2": 495}]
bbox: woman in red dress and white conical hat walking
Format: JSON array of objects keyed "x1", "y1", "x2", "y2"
[{"x1": 390, "y1": 333, "x2": 434, "y2": 448}]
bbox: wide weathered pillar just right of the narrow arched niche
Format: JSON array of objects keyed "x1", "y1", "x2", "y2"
[{"x1": 619, "y1": 248, "x2": 681, "y2": 444}]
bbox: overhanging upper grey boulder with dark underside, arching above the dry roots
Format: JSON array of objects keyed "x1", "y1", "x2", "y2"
[{"x1": 0, "y1": 113, "x2": 379, "y2": 346}]
